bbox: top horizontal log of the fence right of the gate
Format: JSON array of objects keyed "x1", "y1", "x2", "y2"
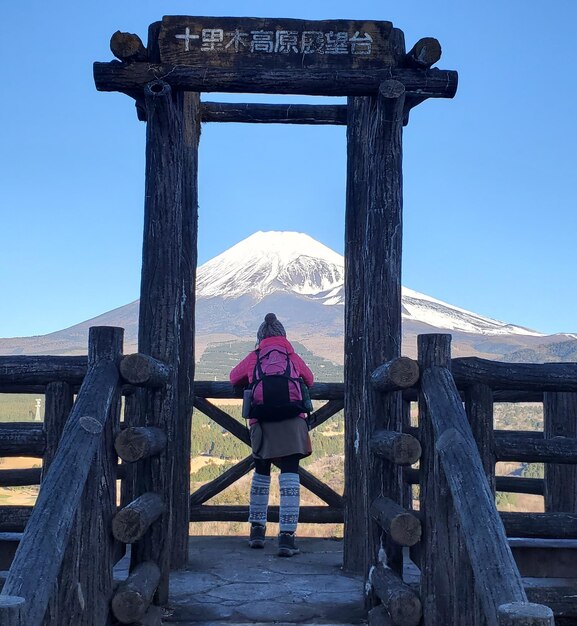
[{"x1": 451, "y1": 357, "x2": 577, "y2": 392}]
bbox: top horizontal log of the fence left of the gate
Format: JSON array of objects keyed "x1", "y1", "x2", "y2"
[{"x1": 0, "y1": 356, "x2": 88, "y2": 387}]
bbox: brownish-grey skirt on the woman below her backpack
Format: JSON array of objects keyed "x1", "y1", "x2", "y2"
[{"x1": 250, "y1": 417, "x2": 312, "y2": 459}]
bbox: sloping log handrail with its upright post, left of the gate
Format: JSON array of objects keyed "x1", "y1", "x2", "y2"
[{"x1": 0, "y1": 327, "x2": 123, "y2": 626}]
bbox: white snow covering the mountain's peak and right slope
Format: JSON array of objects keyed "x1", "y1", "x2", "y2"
[{"x1": 197, "y1": 231, "x2": 543, "y2": 336}]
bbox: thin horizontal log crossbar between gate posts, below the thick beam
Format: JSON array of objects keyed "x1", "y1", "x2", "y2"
[{"x1": 200, "y1": 102, "x2": 347, "y2": 125}]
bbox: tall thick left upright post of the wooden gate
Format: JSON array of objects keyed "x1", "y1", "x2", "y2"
[{"x1": 133, "y1": 75, "x2": 199, "y2": 604}]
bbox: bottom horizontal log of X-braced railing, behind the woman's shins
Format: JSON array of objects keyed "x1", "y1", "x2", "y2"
[{"x1": 190, "y1": 504, "x2": 344, "y2": 524}]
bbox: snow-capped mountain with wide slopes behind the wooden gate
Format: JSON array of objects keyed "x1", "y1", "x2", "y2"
[{"x1": 0, "y1": 232, "x2": 577, "y2": 363}]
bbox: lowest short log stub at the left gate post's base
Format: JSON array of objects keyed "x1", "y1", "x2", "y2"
[{"x1": 111, "y1": 561, "x2": 160, "y2": 624}]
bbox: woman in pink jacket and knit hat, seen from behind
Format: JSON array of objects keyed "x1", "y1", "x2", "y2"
[{"x1": 230, "y1": 313, "x2": 313, "y2": 556}]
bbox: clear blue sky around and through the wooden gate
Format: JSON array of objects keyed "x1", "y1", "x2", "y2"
[{"x1": 0, "y1": 0, "x2": 577, "y2": 337}]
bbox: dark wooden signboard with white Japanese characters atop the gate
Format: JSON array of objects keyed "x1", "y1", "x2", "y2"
[{"x1": 159, "y1": 16, "x2": 399, "y2": 70}]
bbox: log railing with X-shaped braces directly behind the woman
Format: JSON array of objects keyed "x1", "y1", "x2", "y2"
[{"x1": 190, "y1": 381, "x2": 344, "y2": 524}]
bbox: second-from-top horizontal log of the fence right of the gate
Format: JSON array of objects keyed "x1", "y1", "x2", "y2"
[{"x1": 495, "y1": 434, "x2": 577, "y2": 463}]
